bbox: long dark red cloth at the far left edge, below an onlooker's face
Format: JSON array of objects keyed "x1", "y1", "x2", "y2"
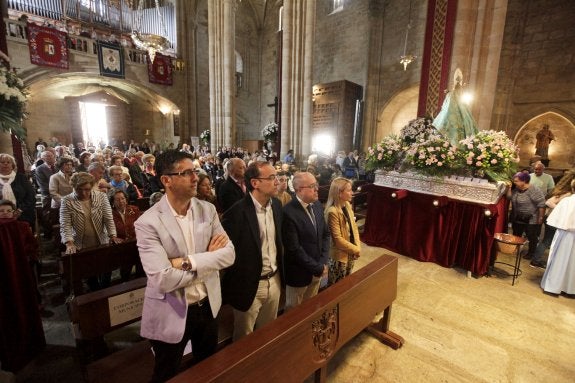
[{"x1": 0, "y1": 221, "x2": 46, "y2": 372}]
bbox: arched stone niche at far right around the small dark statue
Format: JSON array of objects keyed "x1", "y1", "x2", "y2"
[{"x1": 513, "y1": 111, "x2": 575, "y2": 169}]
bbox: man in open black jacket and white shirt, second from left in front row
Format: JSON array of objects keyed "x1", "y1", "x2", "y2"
[{"x1": 222, "y1": 161, "x2": 282, "y2": 341}]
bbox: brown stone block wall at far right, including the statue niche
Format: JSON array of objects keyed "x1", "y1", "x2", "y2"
[{"x1": 492, "y1": 0, "x2": 575, "y2": 167}]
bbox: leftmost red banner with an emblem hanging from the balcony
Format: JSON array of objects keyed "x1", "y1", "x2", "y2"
[{"x1": 28, "y1": 23, "x2": 69, "y2": 69}]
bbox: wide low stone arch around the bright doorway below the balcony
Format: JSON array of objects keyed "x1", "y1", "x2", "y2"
[{"x1": 24, "y1": 72, "x2": 180, "y2": 145}]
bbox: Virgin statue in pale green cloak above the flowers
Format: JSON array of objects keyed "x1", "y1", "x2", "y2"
[{"x1": 433, "y1": 68, "x2": 479, "y2": 146}]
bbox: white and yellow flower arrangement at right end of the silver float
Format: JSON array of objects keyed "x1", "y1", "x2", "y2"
[{"x1": 459, "y1": 130, "x2": 519, "y2": 181}]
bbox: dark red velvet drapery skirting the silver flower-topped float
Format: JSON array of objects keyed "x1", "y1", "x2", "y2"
[{"x1": 362, "y1": 185, "x2": 508, "y2": 275}]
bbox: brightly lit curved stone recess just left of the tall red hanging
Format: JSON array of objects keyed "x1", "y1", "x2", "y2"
[{"x1": 375, "y1": 85, "x2": 419, "y2": 142}]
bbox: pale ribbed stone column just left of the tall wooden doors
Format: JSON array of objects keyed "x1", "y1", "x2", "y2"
[{"x1": 278, "y1": 0, "x2": 316, "y2": 160}]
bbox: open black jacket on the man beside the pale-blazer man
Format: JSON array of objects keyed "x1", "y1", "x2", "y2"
[{"x1": 222, "y1": 193, "x2": 282, "y2": 311}]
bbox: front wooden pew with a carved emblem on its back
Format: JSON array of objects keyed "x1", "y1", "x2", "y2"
[{"x1": 170, "y1": 254, "x2": 403, "y2": 383}]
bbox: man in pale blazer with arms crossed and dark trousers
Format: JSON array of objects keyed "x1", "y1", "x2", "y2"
[{"x1": 135, "y1": 150, "x2": 235, "y2": 382}]
